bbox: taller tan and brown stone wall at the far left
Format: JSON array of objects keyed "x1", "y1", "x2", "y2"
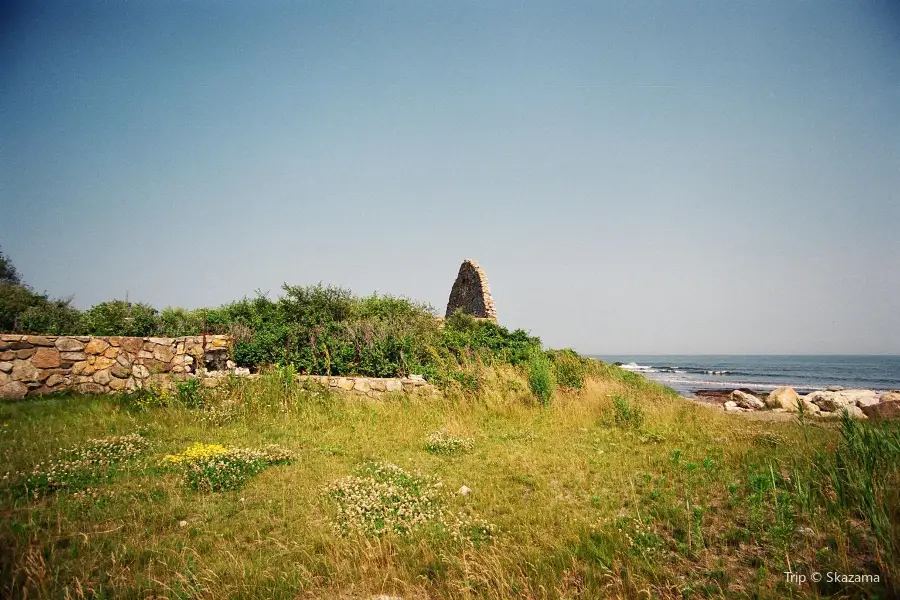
[{"x1": 0, "y1": 334, "x2": 232, "y2": 398}]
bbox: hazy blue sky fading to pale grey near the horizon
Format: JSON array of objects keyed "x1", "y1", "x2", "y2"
[{"x1": 0, "y1": 0, "x2": 900, "y2": 355}]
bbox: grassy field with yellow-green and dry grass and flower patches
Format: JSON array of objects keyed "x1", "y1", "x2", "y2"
[{"x1": 0, "y1": 367, "x2": 900, "y2": 599}]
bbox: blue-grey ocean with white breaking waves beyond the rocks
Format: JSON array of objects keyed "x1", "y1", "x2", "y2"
[{"x1": 594, "y1": 355, "x2": 900, "y2": 395}]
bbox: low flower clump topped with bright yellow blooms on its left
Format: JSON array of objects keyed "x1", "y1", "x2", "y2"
[{"x1": 163, "y1": 443, "x2": 293, "y2": 492}]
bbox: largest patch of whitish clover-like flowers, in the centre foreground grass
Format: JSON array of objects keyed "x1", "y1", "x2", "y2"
[{"x1": 328, "y1": 463, "x2": 496, "y2": 542}]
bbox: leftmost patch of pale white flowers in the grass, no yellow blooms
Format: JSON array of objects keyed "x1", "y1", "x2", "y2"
[{"x1": 18, "y1": 434, "x2": 149, "y2": 497}]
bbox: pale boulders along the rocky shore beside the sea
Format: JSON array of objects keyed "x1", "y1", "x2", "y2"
[{"x1": 694, "y1": 387, "x2": 900, "y2": 419}]
